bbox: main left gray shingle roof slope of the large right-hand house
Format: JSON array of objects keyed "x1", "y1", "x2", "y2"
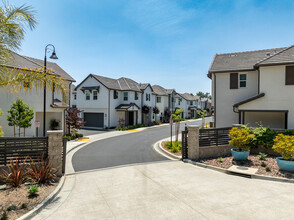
[{"x1": 208, "y1": 47, "x2": 287, "y2": 73}]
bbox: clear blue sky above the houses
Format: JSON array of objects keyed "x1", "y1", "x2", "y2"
[{"x1": 10, "y1": 0, "x2": 294, "y2": 94}]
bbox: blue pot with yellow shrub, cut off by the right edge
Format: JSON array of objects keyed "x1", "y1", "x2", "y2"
[{"x1": 273, "y1": 134, "x2": 294, "y2": 172}]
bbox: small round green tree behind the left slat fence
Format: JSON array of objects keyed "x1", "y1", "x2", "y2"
[{"x1": 7, "y1": 98, "x2": 34, "y2": 136}]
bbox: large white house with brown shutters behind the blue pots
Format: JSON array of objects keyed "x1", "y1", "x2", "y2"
[{"x1": 208, "y1": 46, "x2": 294, "y2": 129}]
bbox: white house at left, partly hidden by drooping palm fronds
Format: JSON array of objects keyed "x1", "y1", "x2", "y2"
[{"x1": 0, "y1": 52, "x2": 75, "y2": 136}]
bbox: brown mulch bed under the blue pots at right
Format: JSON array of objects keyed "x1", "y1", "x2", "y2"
[{"x1": 201, "y1": 155, "x2": 294, "y2": 179}]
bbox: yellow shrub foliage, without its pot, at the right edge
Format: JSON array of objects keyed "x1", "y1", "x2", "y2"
[{"x1": 273, "y1": 134, "x2": 294, "y2": 160}]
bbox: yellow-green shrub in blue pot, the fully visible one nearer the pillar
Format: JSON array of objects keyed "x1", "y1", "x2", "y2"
[{"x1": 229, "y1": 127, "x2": 255, "y2": 160}]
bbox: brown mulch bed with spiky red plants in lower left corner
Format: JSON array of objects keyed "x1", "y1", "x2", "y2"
[{"x1": 0, "y1": 179, "x2": 59, "y2": 220}]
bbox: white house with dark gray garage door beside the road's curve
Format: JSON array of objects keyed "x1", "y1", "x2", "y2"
[{"x1": 75, "y1": 74, "x2": 145, "y2": 128}]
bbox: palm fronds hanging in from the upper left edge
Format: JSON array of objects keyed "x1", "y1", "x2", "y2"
[{"x1": 0, "y1": 1, "x2": 68, "y2": 135}]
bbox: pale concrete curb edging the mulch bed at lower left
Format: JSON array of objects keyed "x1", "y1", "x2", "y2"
[{"x1": 17, "y1": 176, "x2": 65, "y2": 220}]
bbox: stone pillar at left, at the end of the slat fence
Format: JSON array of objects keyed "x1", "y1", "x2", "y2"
[{"x1": 47, "y1": 130, "x2": 63, "y2": 176}]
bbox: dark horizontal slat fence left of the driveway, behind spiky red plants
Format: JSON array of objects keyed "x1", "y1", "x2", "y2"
[{"x1": 0, "y1": 137, "x2": 48, "y2": 165}]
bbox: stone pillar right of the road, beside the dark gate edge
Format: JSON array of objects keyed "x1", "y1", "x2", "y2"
[{"x1": 188, "y1": 125, "x2": 200, "y2": 160}]
